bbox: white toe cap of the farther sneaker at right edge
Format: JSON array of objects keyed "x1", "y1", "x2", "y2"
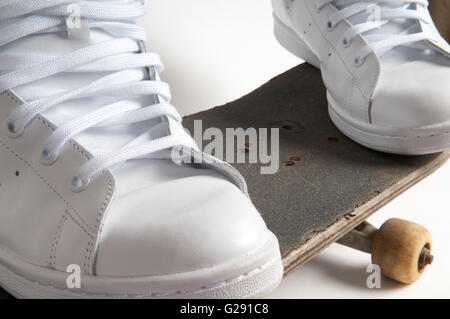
[{"x1": 371, "y1": 61, "x2": 450, "y2": 128}]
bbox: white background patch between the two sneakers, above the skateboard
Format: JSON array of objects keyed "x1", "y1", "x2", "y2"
[{"x1": 141, "y1": 0, "x2": 299, "y2": 115}]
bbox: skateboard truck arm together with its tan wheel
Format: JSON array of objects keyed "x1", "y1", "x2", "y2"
[{"x1": 337, "y1": 218, "x2": 434, "y2": 284}]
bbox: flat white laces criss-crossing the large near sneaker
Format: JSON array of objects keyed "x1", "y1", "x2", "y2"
[{"x1": 0, "y1": 0, "x2": 196, "y2": 191}]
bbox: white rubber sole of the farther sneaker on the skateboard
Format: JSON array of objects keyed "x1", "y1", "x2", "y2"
[{"x1": 274, "y1": 16, "x2": 450, "y2": 155}]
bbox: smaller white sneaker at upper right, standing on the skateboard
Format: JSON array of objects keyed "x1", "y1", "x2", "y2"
[{"x1": 272, "y1": 0, "x2": 450, "y2": 154}]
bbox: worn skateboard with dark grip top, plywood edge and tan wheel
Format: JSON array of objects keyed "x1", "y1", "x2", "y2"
[{"x1": 183, "y1": 63, "x2": 449, "y2": 283}]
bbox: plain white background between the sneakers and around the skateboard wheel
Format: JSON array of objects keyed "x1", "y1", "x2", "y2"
[{"x1": 141, "y1": 0, "x2": 450, "y2": 298}]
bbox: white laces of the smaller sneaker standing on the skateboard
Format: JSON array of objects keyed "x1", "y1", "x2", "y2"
[{"x1": 315, "y1": 0, "x2": 439, "y2": 65}]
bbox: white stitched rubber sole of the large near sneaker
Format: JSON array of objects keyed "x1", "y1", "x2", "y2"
[{"x1": 0, "y1": 233, "x2": 283, "y2": 299}]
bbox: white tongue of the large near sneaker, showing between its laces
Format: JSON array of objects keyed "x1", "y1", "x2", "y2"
[{"x1": 0, "y1": 0, "x2": 207, "y2": 193}]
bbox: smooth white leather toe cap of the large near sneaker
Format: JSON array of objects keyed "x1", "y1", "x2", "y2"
[{"x1": 96, "y1": 176, "x2": 271, "y2": 276}]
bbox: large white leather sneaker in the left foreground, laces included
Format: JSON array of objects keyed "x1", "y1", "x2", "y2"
[{"x1": 0, "y1": 0, "x2": 283, "y2": 298}]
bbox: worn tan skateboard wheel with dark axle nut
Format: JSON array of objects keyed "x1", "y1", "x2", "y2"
[{"x1": 372, "y1": 218, "x2": 433, "y2": 284}]
